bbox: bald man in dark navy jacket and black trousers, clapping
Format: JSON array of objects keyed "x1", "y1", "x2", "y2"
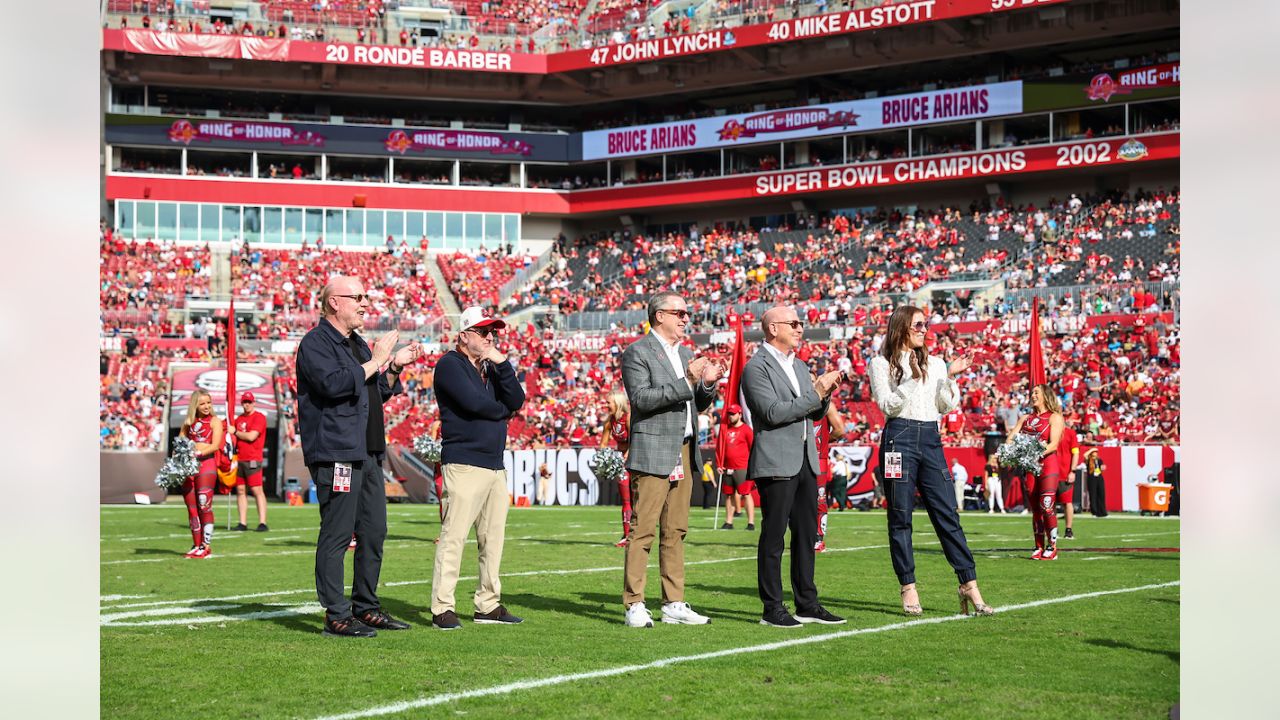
[{"x1": 297, "y1": 275, "x2": 422, "y2": 638}]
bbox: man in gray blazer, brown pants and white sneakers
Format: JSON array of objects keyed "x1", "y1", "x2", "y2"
[{"x1": 622, "y1": 292, "x2": 723, "y2": 628}]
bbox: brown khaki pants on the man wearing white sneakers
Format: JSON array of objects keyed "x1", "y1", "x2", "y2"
[{"x1": 622, "y1": 445, "x2": 694, "y2": 606}]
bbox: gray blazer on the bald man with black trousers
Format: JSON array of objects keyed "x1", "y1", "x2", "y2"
[{"x1": 742, "y1": 346, "x2": 828, "y2": 479}]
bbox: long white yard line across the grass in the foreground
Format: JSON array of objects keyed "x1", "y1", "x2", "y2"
[{"x1": 307, "y1": 580, "x2": 1180, "y2": 720}]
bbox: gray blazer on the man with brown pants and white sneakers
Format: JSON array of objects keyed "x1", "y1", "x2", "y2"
[{"x1": 622, "y1": 333, "x2": 716, "y2": 477}]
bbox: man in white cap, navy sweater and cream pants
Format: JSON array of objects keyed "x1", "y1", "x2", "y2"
[{"x1": 431, "y1": 307, "x2": 525, "y2": 630}]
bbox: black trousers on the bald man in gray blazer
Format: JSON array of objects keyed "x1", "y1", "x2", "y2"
[{"x1": 755, "y1": 454, "x2": 818, "y2": 615}]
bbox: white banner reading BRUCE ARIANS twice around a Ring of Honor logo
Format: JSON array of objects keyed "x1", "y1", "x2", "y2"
[{"x1": 582, "y1": 81, "x2": 1023, "y2": 160}]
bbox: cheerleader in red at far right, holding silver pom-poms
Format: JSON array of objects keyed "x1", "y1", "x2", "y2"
[{"x1": 1009, "y1": 384, "x2": 1066, "y2": 560}]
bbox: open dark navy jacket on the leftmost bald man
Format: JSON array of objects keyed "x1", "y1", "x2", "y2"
[{"x1": 297, "y1": 319, "x2": 403, "y2": 465}]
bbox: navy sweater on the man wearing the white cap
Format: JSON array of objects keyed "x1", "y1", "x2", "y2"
[{"x1": 435, "y1": 350, "x2": 525, "y2": 470}]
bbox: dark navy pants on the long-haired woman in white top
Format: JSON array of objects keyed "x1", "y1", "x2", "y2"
[{"x1": 879, "y1": 418, "x2": 978, "y2": 585}]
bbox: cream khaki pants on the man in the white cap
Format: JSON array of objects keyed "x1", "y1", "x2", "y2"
[{"x1": 431, "y1": 462, "x2": 511, "y2": 615}]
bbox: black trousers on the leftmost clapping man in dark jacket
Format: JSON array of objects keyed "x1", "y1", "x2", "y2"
[{"x1": 307, "y1": 454, "x2": 387, "y2": 619}]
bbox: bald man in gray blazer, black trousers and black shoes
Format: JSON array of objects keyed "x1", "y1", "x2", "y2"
[{"x1": 742, "y1": 306, "x2": 845, "y2": 628}]
